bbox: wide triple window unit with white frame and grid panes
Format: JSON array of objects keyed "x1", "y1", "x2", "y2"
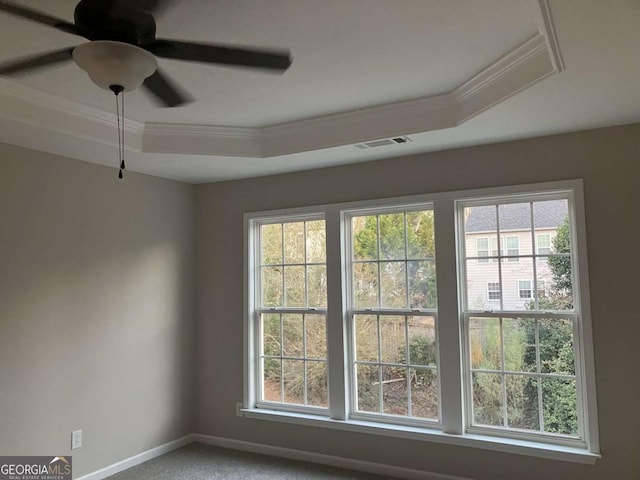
[{"x1": 244, "y1": 181, "x2": 598, "y2": 461}]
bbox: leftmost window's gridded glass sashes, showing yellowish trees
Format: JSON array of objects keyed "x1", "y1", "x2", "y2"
[{"x1": 256, "y1": 218, "x2": 328, "y2": 408}]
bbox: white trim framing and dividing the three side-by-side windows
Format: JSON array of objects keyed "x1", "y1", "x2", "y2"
[{"x1": 243, "y1": 180, "x2": 600, "y2": 464}]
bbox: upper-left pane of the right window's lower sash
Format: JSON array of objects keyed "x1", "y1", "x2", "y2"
[{"x1": 469, "y1": 318, "x2": 502, "y2": 370}]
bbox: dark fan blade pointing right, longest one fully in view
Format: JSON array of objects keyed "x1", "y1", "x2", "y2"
[{"x1": 143, "y1": 39, "x2": 291, "y2": 71}]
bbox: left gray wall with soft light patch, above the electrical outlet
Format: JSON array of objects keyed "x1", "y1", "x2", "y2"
[{"x1": 0, "y1": 144, "x2": 195, "y2": 477}]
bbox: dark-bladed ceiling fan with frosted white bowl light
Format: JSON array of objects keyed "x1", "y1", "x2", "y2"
[{"x1": 0, "y1": 0, "x2": 291, "y2": 107}]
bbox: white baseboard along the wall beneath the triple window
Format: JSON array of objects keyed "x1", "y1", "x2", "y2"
[{"x1": 191, "y1": 433, "x2": 471, "y2": 480}]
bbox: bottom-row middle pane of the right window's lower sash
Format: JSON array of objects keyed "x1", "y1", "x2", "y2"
[{"x1": 505, "y1": 375, "x2": 540, "y2": 430}]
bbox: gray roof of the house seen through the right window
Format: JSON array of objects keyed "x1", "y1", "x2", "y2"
[{"x1": 465, "y1": 200, "x2": 569, "y2": 232}]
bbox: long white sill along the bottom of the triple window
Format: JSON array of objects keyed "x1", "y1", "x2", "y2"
[{"x1": 242, "y1": 409, "x2": 600, "y2": 465}]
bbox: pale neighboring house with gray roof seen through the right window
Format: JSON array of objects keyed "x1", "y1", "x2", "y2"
[{"x1": 465, "y1": 200, "x2": 568, "y2": 310}]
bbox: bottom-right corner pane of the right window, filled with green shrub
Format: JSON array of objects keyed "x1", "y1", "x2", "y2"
[{"x1": 542, "y1": 378, "x2": 578, "y2": 435}]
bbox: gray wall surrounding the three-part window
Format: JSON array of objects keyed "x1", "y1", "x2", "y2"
[{"x1": 196, "y1": 125, "x2": 640, "y2": 480}]
